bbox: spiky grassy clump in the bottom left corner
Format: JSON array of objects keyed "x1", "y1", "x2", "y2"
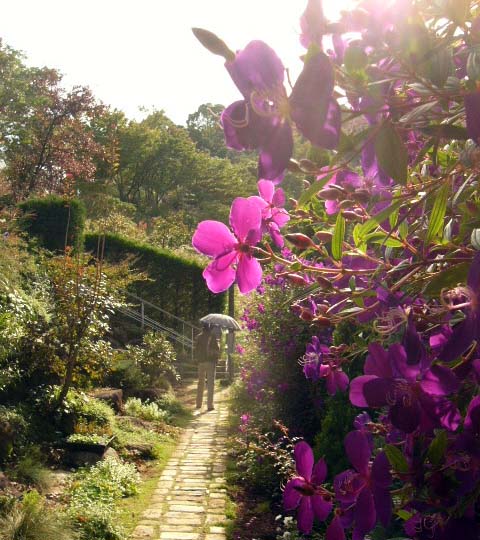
[{"x1": 0, "y1": 491, "x2": 78, "y2": 540}]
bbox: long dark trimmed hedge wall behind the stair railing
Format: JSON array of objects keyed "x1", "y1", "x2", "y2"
[{"x1": 85, "y1": 233, "x2": 226, "y2": 323}]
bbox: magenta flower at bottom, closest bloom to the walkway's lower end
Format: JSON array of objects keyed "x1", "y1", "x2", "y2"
[{"x1": 283, "y1": 441, "x2": 332, "y2": 534}]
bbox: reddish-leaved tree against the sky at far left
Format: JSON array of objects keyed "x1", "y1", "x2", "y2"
[{"x1": 0, "y1": 43, "x2": 103, "y2": 198}]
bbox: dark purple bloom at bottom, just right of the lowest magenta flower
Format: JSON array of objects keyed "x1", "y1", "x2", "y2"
[{"x1": 334, "y1": 431, "x2": 392, "y2": 540}]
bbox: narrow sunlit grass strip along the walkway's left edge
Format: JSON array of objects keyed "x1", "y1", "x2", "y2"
[{"x1": 117, "y1": 439, "x2": 176, "y2": 535}]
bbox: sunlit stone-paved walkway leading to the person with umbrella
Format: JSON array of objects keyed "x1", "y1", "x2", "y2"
[{"x1": 131, "y1": 387, "x2": 228, "y2": 540}]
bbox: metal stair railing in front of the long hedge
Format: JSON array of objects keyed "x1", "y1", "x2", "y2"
[{"x1": 119, "y1": 291, "x2": 200, "y2": 360}]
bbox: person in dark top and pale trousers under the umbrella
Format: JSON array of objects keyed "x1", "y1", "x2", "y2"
[{"x1": 195, "y1": 325, "x2": 220, "y2": 411}]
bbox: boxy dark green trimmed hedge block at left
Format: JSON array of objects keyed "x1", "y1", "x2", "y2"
[{"x1": 18, "y1": 195, "x2": 86, "y2": 251}]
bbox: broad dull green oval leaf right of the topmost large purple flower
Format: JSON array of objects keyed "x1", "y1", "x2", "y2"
[{"x1": 375, "y1": 122, "x2": 408, "y2": 184}]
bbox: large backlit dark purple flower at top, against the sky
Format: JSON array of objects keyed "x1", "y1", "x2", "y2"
[{"x1": 221, "y1": 41, "x2": 340, "y2": 182}]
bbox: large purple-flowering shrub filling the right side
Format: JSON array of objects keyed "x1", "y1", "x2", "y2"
[{"x1": 193, "y1": 0, "x2": 480, "y2": 540}]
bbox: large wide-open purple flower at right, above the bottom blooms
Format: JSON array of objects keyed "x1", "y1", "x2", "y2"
[{"x1": 350, "y1": 343, "x2": 460, "y2": 433}]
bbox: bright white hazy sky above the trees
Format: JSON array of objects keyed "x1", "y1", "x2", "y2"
[{"x1": 0, "y1": 0, "x2": 350, "y2": 124}]
